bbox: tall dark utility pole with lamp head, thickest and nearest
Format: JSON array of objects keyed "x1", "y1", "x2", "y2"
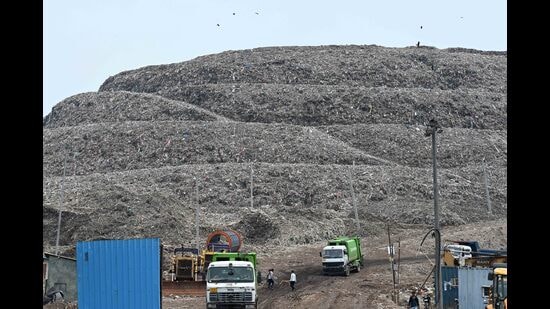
[{"x1": 424, "y1": 118, "x2": 443, "y2": 309}]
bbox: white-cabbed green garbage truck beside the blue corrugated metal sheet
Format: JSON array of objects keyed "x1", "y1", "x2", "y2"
[{"x1": 206, "y1": 252, "x2": 261, "y2": 308}]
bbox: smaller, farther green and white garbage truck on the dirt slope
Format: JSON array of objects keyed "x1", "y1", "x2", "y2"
[{"x1": 319, "y1": 236, "x2": 363, "y2": 276}]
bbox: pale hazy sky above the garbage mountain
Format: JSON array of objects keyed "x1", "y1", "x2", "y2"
[{"x1": 43, "y1": 0, "x2": 507, "y2": 116}]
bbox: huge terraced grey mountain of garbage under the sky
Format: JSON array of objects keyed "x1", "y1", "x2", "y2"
[{"x1": 43, "y1": 45, "x2": 507, "y2": 255}]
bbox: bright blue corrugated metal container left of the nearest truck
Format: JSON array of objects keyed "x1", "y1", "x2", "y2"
[{"x1": 76, "y1": 238, "x2": 162, "y2": 309}]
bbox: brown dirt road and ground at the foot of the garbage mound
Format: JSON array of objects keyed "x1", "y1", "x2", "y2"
[{"x1": 163, "y1": 220, "x2": 507, "y2": 309}]
